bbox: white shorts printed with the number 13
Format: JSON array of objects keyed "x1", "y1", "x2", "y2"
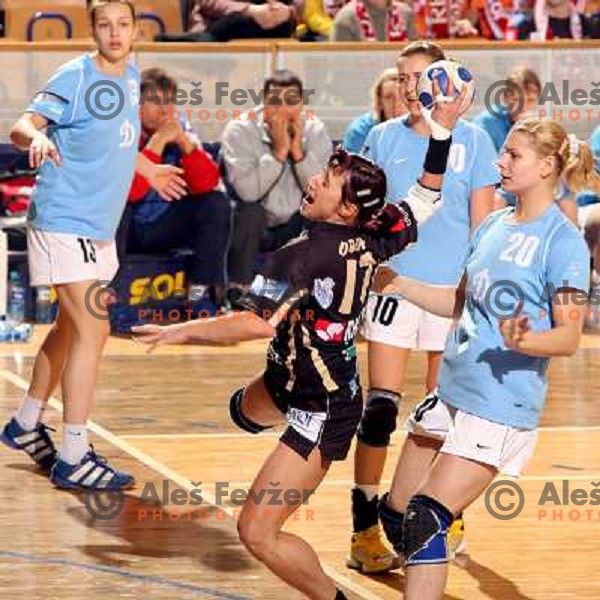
[{"x1": 27, "y1": 227, "x2": 119, "y2": 287}]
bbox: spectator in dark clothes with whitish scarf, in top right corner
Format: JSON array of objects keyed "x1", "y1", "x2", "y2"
[{"x1": 523, "y1": 0, "x2": 600, "y2": 41}]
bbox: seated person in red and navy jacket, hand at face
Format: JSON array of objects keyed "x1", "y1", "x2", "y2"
[{"x1": 128, "y1": 69, "x2": 231, "y2": 302}]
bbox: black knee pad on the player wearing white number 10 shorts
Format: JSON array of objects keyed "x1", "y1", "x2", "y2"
[{"x1": 358, "y1": 389, "x2": 400, "y2": 448}]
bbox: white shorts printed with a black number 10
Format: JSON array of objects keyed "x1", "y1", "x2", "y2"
[{"x1": 363, "y1": 293, "x2": 452, "y2": 352}]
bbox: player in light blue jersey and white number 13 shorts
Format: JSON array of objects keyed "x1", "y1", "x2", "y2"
[{"x1": 1, "y1": 0, "x2": 185, "y2": 490}]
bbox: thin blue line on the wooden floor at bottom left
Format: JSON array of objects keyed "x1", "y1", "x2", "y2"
[{"x1": 0, "y1": 550, "x2": 250, "y2": 600}]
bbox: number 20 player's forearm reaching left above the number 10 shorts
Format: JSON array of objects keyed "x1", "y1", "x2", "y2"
[{"x1": 372, "y1": 267, "x2": 466, "y2": 318}]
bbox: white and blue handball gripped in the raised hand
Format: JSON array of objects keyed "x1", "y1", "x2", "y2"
[{"x1": 417, "y1": 60, "x2": 475, "y2": 114}]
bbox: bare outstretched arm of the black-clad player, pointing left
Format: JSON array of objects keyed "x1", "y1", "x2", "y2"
[{"x1": 132, "y1": 311, "x2": 275, "y2": 352}]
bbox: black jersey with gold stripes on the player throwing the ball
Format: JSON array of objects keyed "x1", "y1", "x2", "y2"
[{"x1": 241, "y1": 203, "x2": 417, "y2": 394}]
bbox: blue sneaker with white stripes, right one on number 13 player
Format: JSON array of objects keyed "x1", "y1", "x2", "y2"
[{"x1": 50, "y1": 446, "x2": 135, "y2": 491}]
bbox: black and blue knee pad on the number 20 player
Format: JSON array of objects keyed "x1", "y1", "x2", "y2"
[{"x1": 402, "y1": 495, "x2": 453, "y2": 566}]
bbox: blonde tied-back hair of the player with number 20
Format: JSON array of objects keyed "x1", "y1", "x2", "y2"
[{"x1": 511, "y1": 117, "x2": 600, "y2": 193}]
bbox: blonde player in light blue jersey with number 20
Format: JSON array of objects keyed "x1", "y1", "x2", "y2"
[{"x1": 376, "y1": 118, "x2": 598, "y2": 600}]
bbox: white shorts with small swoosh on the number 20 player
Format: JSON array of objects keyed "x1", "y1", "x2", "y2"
[{"x1": 406, "y1": 394, "x2": 538, "y2": 477}]
